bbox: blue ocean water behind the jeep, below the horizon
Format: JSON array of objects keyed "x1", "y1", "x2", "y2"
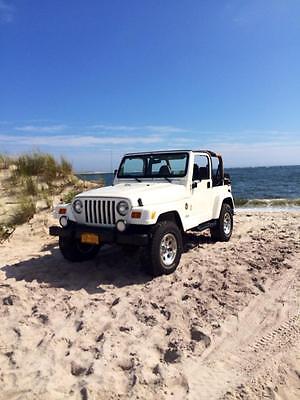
[{"x1": 78, "y1": 165, "x2": 300, "y2": 208}]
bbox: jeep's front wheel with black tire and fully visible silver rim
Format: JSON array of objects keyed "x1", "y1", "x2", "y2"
[{"x1": 141, "y1": 221, "x2": 182, "y2": 276}]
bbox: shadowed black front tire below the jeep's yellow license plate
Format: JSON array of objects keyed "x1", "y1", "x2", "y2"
[{"x1": 58, "y1": 236, "x2": 100, "y2": 262}]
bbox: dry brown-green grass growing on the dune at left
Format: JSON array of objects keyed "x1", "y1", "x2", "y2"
[{"x1": 0, "y1": 152, "x2": 75, "y2": 243}]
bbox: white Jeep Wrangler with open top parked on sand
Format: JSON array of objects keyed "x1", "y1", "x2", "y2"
[{"x1": 50, "y1": 150, "x2": 234, "y2": 276}]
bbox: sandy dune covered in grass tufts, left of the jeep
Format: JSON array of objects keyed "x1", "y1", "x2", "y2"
[{"x1": 0, "y1": 152, "x2": 102, "y2": 243}]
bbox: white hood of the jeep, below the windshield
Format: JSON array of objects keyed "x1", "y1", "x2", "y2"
[{"x1": 76, "y1": 182, "x2": 186, "y2": 206}]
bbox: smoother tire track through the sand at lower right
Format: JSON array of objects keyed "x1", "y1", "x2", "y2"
[{"x1": 184, "y1": 261, "x2": 300, "y2": 400}]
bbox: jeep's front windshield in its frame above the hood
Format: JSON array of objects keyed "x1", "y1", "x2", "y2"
[{"x1": 117, "y1": 153, "x2": 189, "y2": 179}]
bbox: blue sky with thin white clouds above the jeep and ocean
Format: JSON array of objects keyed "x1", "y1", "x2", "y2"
[{"x1": 0, "y1": 0, "x2": 300, "y2": 171}]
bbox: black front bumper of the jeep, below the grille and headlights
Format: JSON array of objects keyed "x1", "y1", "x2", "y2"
[{"x1": 49, "y1": 224, "x2": 149, "y2": 246}]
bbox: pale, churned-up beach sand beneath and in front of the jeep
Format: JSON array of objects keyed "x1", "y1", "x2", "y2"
[{"x1": 0, "y1": 212, "x2": 300, "y2": 400}]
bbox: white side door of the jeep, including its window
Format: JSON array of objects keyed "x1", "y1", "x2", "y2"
[{"x1": 191, "y1": 153, "x2": 213, "y2": 226}]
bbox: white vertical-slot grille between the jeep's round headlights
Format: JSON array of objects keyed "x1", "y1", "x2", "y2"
[{"x1": 84, "y1": 200, "x2": 116, "y2": 225}]
